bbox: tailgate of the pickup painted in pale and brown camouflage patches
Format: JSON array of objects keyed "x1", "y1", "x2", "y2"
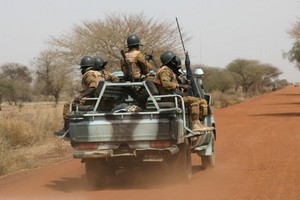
[{"x1": 70, "y1": 113, "x2": 183, "y2": 142}]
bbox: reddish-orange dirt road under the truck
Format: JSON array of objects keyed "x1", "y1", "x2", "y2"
[{"x1": 0, "y1": 87, "x2": 300, "y2": 200}]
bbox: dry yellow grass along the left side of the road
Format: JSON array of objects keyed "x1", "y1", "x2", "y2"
[{"x1": 0, "y1": 103, "x2": 71, "y2": 176}]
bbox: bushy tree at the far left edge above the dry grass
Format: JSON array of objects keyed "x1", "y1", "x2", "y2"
[{"x1": 1, "y1": 63, "x2": 32, "y2": 104}]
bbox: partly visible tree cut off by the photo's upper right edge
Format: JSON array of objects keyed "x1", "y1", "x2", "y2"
[{"x1": 283, "y1": 21, "x2": 300, "y2": 70}]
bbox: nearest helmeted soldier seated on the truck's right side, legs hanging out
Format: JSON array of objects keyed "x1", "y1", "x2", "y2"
[{"x1": 154, "y1": 51, "x2": 207, "y2": 131}]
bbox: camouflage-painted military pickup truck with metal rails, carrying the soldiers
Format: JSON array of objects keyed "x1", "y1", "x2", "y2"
[{"x1": 61, "y1": 69, "x2": 216, "y2": 185}]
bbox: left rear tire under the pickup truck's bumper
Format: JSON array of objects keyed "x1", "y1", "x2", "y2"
[{"x1": 85, "y1": 159, "x2": 108, "y2": 187}]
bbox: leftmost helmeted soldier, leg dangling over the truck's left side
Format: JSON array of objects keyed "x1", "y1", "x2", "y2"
[{"x1": 54, "y1": 56, "x2": 104, "y2": 136}]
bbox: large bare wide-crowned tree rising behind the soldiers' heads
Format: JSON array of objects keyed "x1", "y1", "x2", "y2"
[{"x1": 49, "y1": 13, "x2": 189, "y2": 71}]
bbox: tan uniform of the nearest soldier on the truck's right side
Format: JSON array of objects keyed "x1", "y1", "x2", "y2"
[{"x1": 154, "y1": 65, "x2": 207, "y2": 131}]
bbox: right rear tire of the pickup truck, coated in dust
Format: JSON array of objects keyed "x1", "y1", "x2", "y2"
[{"x1": 174, "y1": 143, "x2": 192, "y2": 181}]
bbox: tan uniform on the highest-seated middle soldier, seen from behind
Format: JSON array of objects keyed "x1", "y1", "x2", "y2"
[{"x1": 121, "y1": 49, "x2": 153, "y2": 81}]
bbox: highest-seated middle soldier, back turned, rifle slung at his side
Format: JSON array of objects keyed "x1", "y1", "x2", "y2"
[{"x1": 121, "y1": 35, "x2": 153, "y2": 81}]
